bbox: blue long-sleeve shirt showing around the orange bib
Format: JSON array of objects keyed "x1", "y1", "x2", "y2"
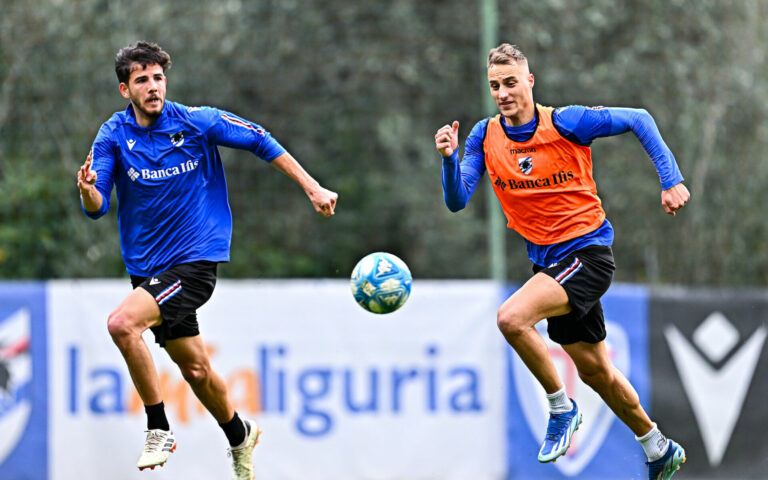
[{"x1": 443, "y1": 105, "x2": 683, "y2": 266}]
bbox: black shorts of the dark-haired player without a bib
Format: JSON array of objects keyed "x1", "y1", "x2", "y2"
[{"x1": 131, "y1": 260, "x2": 218, "y2": 347}]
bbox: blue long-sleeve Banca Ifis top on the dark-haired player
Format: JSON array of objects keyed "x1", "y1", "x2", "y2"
[{"x1": 83, "y1": 101, "x2": 285, "y2": 277}]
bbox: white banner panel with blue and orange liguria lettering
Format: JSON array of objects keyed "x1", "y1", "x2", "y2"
[{"x1": 45, "y1": 281, "x2": 506, "y2": 480}]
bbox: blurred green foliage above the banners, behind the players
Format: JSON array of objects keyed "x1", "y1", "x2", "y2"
[{"x1": 0, "y1": 0, "x2": 768, "y2": 285}]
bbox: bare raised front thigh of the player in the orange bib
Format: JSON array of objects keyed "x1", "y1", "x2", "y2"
[{"x1": 499, "y1": 273, "x2": 571, "y2": 325}]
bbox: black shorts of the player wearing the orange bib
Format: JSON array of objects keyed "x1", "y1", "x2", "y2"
[{"x1": 533, "y1": 245, "x2": 616, "y2": 345}]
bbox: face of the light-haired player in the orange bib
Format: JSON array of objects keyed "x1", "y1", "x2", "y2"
[{"x1": 488, "y1": 62, "x2": 534, "y2": 125}]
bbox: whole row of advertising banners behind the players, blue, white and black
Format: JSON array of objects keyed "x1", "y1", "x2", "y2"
[{"x1": 0, "y1": 280, "x2": 768, "y2": 480}]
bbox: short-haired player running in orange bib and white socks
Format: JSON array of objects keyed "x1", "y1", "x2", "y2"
[{"x1": 435, "y1": 43, "x2": 690, "y2": 480}]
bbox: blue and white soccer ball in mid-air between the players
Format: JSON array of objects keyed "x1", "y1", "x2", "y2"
[{"x1": 349, "y1": 252, "x2": 413, "y2": 313}]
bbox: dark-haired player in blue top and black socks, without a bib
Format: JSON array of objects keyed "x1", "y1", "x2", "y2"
[{"x1": 77, "y1": 42, "x2": 338, "y2": 480}]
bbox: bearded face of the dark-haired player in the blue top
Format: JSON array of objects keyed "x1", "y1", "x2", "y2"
[{"x1": 120, "y1": 63, "x2": 167, "y2": 127}]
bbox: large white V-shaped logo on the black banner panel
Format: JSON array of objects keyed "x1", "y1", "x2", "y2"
[{"x1": 664, "y1": 312, "x2": 768, "y2": 467}]
